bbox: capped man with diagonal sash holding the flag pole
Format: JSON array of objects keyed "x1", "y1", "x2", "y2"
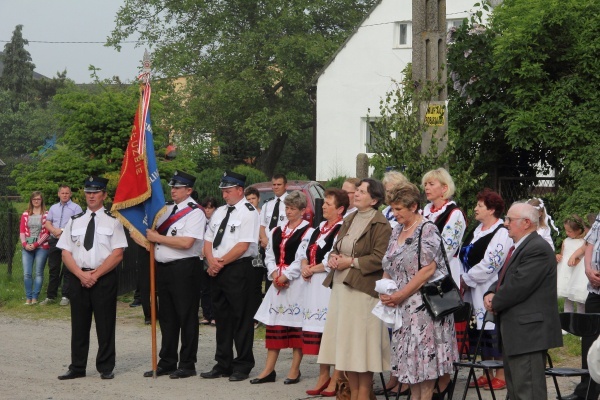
[{"x1": 144, "y1": 171, "x2": 206, "y2": 379}]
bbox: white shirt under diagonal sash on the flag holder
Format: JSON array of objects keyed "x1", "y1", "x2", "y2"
[{"x1": 154, "y1": 197, "x2": 206, "y2": 263}]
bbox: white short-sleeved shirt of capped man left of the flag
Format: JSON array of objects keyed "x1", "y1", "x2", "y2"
[{"x1": 56, "y1": 207, "x2": 127, "y2": 269}]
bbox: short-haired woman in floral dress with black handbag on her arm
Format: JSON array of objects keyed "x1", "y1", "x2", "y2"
[{"x1": 380, "y1": 184, "x2": 458, "y2": 400}]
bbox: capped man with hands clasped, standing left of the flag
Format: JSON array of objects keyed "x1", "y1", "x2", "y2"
[{"x1": 56, "y1": 176, "x2": 127, "y2": 380}]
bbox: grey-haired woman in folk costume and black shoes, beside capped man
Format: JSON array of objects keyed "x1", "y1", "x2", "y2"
[{"x1": 250, "y1": 190, "x2": 311, "y2": 385}]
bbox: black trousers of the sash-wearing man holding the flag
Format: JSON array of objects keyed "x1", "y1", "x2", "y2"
[{"x1": 156, "y1": 257, "x2": 202, "y2": 370}]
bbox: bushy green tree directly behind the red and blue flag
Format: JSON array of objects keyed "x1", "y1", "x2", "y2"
[{"x1": 11, "y1": 77, "x2": 194, "y2": 201}]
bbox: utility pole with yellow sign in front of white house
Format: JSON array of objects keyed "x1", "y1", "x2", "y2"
[{"x1": 412, "y1": 0, "x2": 448, "y2": 153}]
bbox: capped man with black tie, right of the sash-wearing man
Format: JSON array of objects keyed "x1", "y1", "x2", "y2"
[{"x1": 200, "y1": 171, "x2": 259, "y2": 382}]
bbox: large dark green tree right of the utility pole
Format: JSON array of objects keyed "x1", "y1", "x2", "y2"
[{"x1": 448, "y1": 0, "x2": 600, "y2": 216}]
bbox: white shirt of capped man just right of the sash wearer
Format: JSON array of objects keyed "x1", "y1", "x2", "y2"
[{"x1": 205, "y1": 198, "x2": 258, "y2": 258}]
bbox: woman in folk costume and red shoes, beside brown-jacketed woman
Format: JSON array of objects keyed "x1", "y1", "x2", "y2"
[{"x1": 302, "y1": 188, "x2": 350, "y2": 397}]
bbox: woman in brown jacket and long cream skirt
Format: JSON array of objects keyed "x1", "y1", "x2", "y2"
[{"x1": 317, "y1": 179, "x2": 391, "y2": 400}]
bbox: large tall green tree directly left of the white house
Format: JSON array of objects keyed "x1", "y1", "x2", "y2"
[{"x1": 108, "y1": 0, "x2": 375, "y2": 175}]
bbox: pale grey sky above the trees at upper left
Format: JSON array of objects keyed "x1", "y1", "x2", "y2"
[{"x1": 0, "y1": 0, "x2": 144, "y2": 83}]
